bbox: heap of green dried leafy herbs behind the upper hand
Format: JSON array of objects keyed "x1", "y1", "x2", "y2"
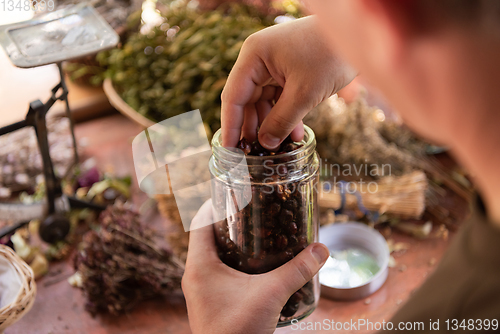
[{"x1": 94, "y1": 4, "x2": 282, "y2": 131}]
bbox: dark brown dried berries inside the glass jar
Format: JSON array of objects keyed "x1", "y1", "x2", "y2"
[{"x1": 214, "y1": 137, "x2": 315, "y2": 319}]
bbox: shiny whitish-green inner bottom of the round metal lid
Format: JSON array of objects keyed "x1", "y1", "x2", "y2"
[{"x1": 319, "y1": 248, "x2": 380, "y2": 288}]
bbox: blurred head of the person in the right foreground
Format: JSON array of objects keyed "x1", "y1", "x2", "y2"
[{"x1": 309, "y1": 0, "x2": 500, "y2": 145}]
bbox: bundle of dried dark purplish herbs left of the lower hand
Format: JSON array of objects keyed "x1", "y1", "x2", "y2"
[{"x1": 75, "y1": 204, "x2": 184, "y2": 315}]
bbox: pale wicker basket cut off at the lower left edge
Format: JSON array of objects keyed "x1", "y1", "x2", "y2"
[{"x1": 0, "y1": 245, "x2": 36, "y2": 333}]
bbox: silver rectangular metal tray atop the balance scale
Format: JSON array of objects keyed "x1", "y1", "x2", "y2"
[{"x1": 0, "y1": 3, "x2": 119, "y2": 68}]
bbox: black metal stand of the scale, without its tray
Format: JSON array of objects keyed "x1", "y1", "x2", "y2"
[{"x1": 0, "y1": 63, "x2": 105, "y2": 243}]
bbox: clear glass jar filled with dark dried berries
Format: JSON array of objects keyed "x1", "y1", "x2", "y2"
[{"x1": 209, "y1": 126, "x2": 319, "y2": 327}]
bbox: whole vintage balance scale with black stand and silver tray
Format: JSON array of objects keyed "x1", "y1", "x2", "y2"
[{"x1": 0, "y1": 4, "x2": 119, "y2": 243}]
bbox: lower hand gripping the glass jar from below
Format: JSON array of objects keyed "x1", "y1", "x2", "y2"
[{"x1": 182, "y1": 201, "x2": 329, "y2": 334}]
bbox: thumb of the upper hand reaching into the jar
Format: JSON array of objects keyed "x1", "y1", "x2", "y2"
[{"x1": 259, "y1": 82, "x2": 321, "y2": 150}]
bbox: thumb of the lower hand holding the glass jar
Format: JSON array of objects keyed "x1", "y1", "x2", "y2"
[{"x1": 266, "y1": 243, "x2": 330, "y2": 303}]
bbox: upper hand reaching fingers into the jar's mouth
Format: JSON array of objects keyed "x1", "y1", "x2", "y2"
[{"x1": 221, "y1": 16, "x2": 356, "y2": 150}]
